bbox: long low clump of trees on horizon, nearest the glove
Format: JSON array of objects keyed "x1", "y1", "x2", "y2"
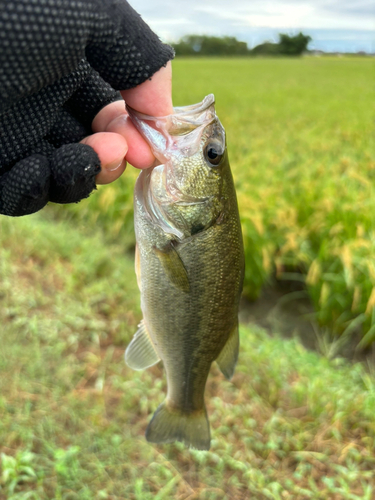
[{"x1": 173, "y1": 35, "x2": 249, "y2": 56}]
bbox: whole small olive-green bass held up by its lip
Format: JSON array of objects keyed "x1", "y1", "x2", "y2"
[{"x1": 125, "y1": 94, "x2": 244, "y2": 450}]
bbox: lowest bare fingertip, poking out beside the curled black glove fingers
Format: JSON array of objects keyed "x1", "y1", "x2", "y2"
[{"x1": 81, "y1": 132, "x2": 128, "y2": 184}]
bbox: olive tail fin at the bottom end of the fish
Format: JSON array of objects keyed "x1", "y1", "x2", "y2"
[{"x1": 146, "y1": 402, "x2": 211, "y2": 450}]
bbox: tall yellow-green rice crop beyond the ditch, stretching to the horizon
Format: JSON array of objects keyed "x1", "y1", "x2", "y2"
[{"x1": 53, "y1": 57, "x2": 375, "y2": 347}]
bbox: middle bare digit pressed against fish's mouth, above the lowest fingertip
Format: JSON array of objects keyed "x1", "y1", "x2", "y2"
[{"x1": 92, "y1": 101, "x2": 155, "y2": 168}]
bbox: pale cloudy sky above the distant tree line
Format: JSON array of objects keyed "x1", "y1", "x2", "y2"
[{"x1": 129, "y1": 0, "x2": 375, "y2": 53}]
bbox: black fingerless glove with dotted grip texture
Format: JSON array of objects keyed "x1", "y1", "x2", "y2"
[{"x1": 0, "y1": 0, "x2": 173, "y2": 216}]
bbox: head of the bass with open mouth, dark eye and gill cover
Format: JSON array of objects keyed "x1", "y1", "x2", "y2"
[{"x1": 127, "y1": 94, "x2": 229, "y2": 240}]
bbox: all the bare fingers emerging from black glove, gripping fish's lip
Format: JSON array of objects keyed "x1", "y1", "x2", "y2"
[{"x1": 88, "y1": 61, "x2": 173, "y2": 184}]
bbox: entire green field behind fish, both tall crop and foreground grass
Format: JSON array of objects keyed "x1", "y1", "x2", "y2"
[{"x1": 0, "y1": 58, "x2": 375, "y2": 500}]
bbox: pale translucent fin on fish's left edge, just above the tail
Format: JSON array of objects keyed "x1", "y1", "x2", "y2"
[{"x1": 125, "y1": 320, "x2": 160, "y2": 370}]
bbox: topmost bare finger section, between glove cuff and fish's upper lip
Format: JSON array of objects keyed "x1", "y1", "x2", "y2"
[{"x1": 121, "y1": 61, "x2": 173, "y2": 116}]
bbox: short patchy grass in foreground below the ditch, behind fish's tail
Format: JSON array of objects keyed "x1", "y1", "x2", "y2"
[{"x1": 0, "y1": 216, "x2": 375, "y2": 500}]
